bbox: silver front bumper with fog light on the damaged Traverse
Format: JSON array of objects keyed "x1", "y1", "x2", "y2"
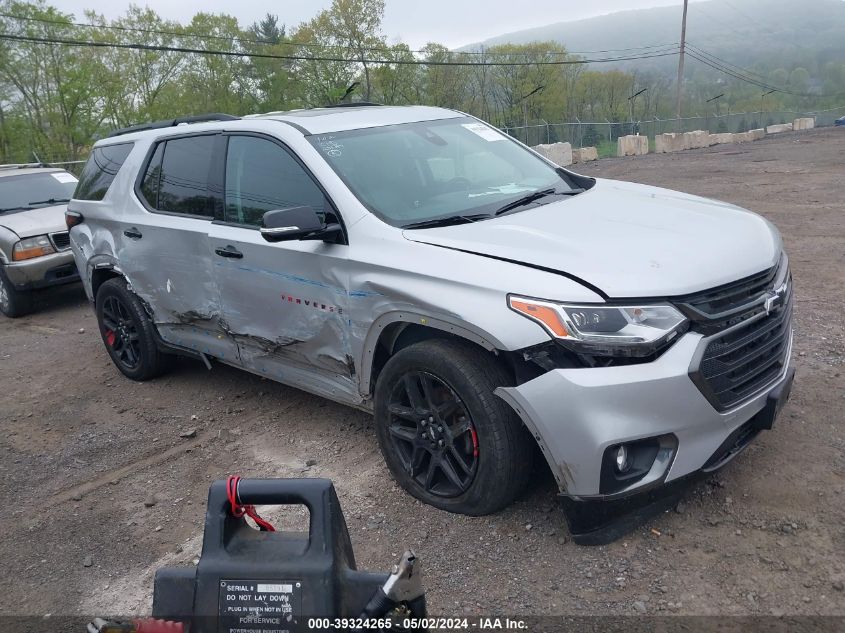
[{"x1": 496, "y1": 332, "x2": 792, "y2": 500}]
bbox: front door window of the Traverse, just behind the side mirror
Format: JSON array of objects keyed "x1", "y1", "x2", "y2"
[{"x1": 224, "y1": 136, "x2": 326, "y2": 226}]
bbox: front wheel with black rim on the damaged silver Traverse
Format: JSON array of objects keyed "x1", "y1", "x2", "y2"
[{"x1": 375, "y1": 339, "x2": 532, "y2": 516}]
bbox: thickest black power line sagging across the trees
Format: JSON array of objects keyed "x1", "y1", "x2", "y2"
[{"x1": 0, "y1": 33, "x2": 678, "y2": 66}]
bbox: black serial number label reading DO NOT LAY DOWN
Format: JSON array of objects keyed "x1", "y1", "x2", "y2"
[{"x1": 218, "y1": 580, "x2": 302, "y2": 633}]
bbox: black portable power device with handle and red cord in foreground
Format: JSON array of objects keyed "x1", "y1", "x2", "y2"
[{"x1": 144, "y1": 478, "x2": 425, "y2": 633}]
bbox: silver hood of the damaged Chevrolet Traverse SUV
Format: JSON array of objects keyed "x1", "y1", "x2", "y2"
[{"x1": 403, "y1": 179, "x2": 782, "y2": 299}]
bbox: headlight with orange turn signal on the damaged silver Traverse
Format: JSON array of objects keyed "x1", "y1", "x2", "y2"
[{"x1": 508, "y1": 295, "x2": 687, "y2": 356}]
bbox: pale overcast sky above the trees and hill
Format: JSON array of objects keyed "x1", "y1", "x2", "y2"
[{"x1": 47, "y1": 0, "x2": 700, "y2": 48}]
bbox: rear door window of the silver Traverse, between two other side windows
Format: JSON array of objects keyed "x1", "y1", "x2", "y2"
[{"x1": 141, "y1": 135, "x2": 217, "y2": 218}]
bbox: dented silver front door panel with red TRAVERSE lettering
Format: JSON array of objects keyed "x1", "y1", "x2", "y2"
[{"x1": 210, "y1": 224, "x2": 360, "y2": 403}]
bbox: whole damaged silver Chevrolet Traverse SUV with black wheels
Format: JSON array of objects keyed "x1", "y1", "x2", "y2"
[{"x1": 67, "y1": 105, "x2": 792, "y2": 540}]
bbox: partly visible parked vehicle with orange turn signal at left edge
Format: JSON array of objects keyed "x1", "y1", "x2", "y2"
[{"x1": 0, "y1": 165, "x2": 79, "y2": 317}]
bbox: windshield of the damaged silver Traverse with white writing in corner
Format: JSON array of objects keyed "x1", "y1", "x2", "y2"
[{"x1": 310, "y1": 117, "x2": 575, "y2": 226}]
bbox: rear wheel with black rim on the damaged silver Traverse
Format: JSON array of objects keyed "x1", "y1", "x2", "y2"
[{"x1": 96, "y1": 277, "x2": 174, "y2": 381}]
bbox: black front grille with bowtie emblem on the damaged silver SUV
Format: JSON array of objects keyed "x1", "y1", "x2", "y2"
[{"x1": 685, "y1": 256, "x2": 792, "y2": 411}]
